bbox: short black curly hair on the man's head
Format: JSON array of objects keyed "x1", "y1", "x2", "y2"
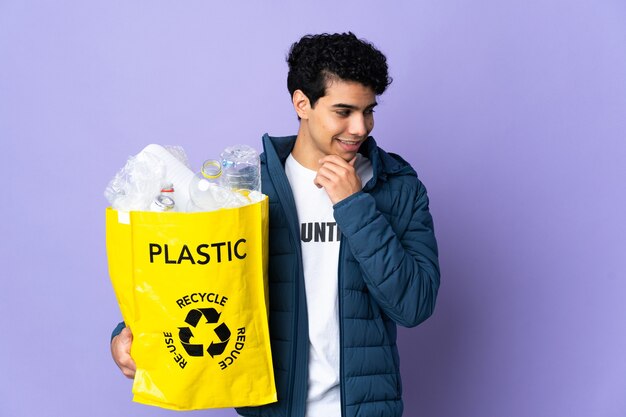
[{"x1": 287, "y1": 32, "x2": 392, "y2": 107}]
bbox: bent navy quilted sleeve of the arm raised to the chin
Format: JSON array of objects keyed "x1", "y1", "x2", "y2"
[{"x1": 335, "y1": 180, "x2": 439, "y2": 327}]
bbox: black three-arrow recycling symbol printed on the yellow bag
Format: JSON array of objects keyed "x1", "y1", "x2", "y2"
[{"x1": 178, "y1": 308, "x2": 230, "y2": 357}]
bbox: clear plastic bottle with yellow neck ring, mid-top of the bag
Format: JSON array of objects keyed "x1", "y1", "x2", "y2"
[{"x1": 187, "y1": 159, "x2": 232, "y2": 211}]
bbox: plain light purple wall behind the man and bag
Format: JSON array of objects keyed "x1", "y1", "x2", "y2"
[{"x1": 0, "y1": 0, "x2": 626, "y2": 417}]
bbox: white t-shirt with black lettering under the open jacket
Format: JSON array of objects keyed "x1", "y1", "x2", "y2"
[{"x1": 285, "y1": 155, "x2": 372, "y2": 417}]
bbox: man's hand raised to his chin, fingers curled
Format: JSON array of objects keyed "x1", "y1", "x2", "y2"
[{"x1": 313, "y1": 155, "x2": 362, "y2": 204}]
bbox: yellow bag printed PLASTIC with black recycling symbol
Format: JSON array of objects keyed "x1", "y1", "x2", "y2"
[{"x1": 106, "y1": 198, "x2": 276, "y2": 410}]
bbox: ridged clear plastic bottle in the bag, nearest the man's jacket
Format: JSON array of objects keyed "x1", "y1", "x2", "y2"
[{"x1": 220, "y1": 145, "x2": 261, "y2": 191}]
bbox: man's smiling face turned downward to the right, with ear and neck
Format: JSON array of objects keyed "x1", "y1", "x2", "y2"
[{"x1": 292, "y1": 79, "x2": 376, "y2": 170}]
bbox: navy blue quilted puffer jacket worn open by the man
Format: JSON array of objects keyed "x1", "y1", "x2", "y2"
[{"x1": 237, "y1": 135, "x2": 439, "y2": 417}]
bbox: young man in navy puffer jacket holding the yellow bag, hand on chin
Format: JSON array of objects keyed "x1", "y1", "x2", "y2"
[{"x1": 111, "y1": 33, "x2": 439, "y2": 417}]
